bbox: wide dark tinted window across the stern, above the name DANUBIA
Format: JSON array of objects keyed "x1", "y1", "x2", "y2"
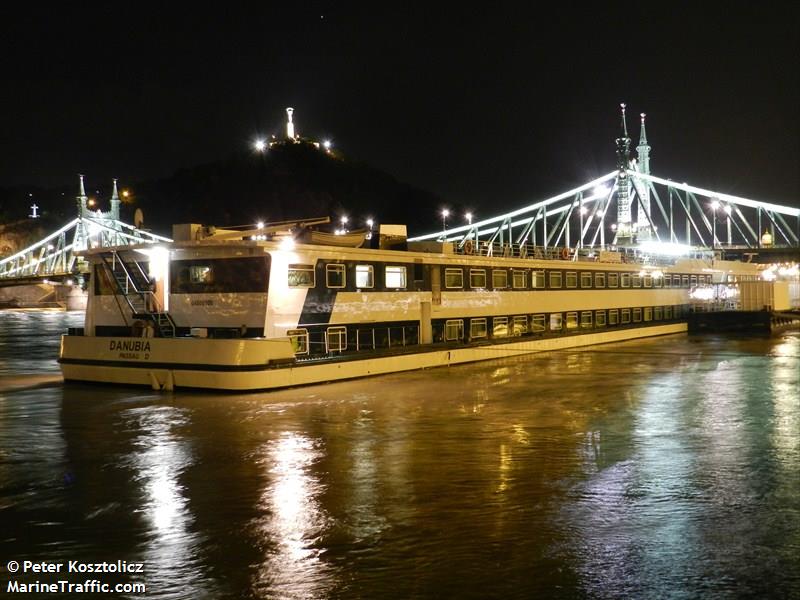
[{"x1": 170, "y1": 256, "x2": 269, "y2": 294}]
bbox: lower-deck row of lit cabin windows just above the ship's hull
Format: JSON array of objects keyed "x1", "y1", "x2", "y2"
[{"x1": 286, "y1": 304, "x2": 682, "y2": 355}]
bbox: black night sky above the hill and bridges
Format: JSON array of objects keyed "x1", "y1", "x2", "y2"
[{"x1": 0, "y1": 2, "x2": 800, "y2": 223}]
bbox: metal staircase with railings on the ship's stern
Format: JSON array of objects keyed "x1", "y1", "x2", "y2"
[{"x1": 100, "y1": 250, "x2": 175, "y2": 337}]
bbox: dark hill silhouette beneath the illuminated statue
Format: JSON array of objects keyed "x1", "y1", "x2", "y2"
[{"x1": 135, "y1": 143, "x2": 441, "y2": 231}]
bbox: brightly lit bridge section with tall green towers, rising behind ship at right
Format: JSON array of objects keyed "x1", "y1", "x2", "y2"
[{"x1": 409, "y1": 104, "x2": 800, "y2": 259}]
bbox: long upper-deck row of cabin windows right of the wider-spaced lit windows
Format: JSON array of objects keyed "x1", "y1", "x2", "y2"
[{"x1": 444, "y1": 267, "x2": 711, "y2": 289}]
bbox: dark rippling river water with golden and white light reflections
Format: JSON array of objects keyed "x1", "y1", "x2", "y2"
[{"x1": 0, "y1": 312, "x2": 800, "y2": 599}]
